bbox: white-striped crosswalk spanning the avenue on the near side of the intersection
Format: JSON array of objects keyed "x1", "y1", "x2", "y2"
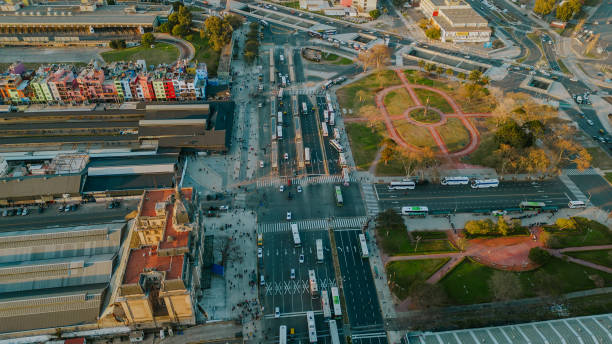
[{"x1": 257, "y1": 216, "x2": 368, "y2": 233}]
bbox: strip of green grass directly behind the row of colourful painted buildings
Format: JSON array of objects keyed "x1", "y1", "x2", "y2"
[{"x1": 101, "y1": 43, "x2": 179, "y2": 65}]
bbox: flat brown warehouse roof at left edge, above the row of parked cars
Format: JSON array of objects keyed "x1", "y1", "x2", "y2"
[{"x1": 0, "y1": 174, "x2": 81, "y2": 199}]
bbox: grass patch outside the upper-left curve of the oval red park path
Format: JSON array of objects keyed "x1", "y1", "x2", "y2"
[{"x1": 336, "y1": 70, "x2": 400, "y2": 117}]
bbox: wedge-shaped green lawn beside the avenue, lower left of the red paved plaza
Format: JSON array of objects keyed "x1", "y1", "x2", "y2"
[{"x1": 386, "y1": 258, "x2": 450, "y2": 300}]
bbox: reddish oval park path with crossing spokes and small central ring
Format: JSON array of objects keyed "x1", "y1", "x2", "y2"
[{"x1": 345, "y1": 69, "x2": 491, "y2": 158}]
